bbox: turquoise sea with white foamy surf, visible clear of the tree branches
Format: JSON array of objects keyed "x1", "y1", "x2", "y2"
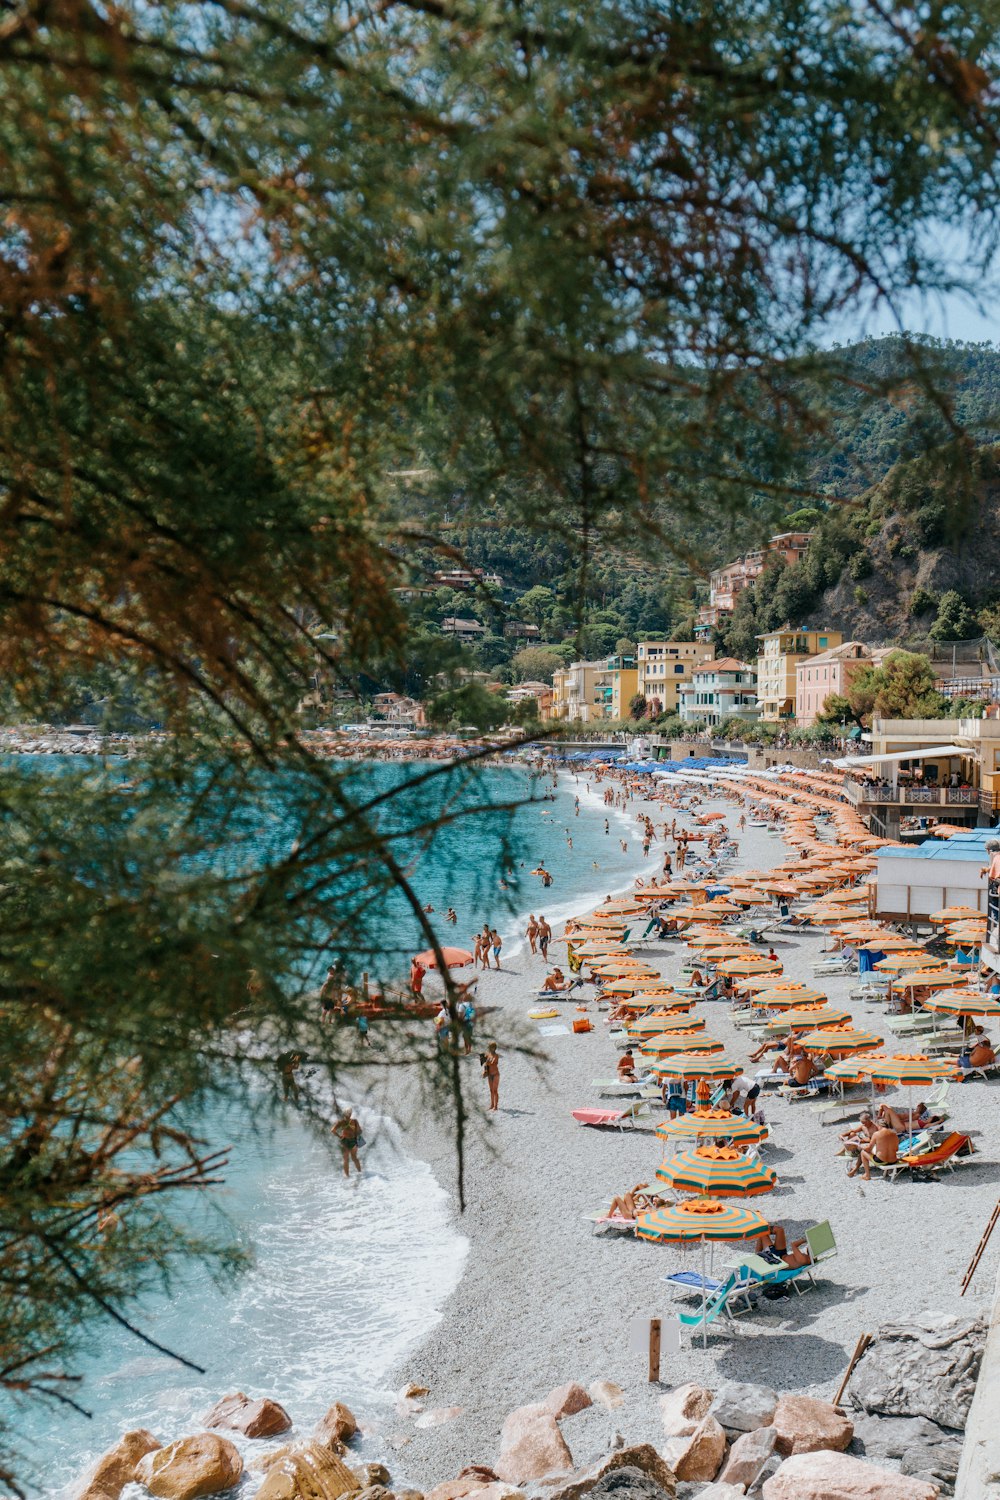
[{"x1": 3, "y1": 764, "x2": 650, "y2": 1500}]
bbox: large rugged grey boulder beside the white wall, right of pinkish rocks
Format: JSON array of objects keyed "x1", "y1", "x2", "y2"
[{"x1": 847, "y1": 1313, "x2": 985, "y2": 1428}]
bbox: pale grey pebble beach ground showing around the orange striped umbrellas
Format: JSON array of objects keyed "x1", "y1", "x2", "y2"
[{"x1": 381, "y1": 774, "x2": 1000, "y2": 1488}]
